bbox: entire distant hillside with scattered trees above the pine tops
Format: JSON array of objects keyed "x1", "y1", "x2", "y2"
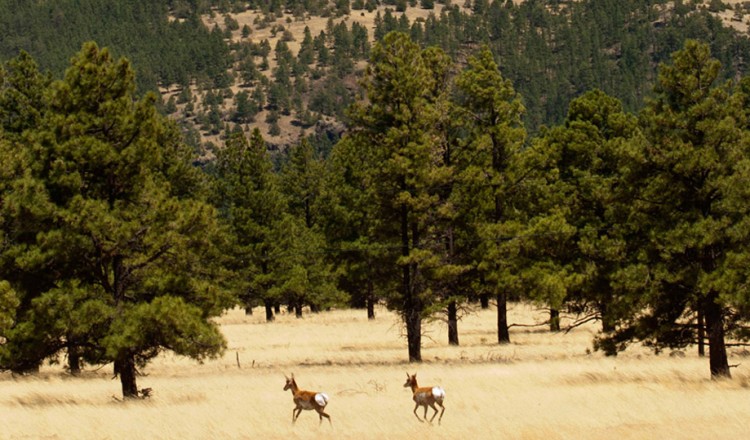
[{"x1": 0, "y1": 0, "x2": 750, "y2": 156}]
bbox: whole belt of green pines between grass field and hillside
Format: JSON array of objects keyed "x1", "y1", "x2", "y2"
[{"x1": 0, "y1": 2, "x2": 750, "y2": 397}]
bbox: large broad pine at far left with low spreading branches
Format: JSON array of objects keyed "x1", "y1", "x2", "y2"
[{"x1": 0, "y1": 43, "x2": 231, "y2": 397}]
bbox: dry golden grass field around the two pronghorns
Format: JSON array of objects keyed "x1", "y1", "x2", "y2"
[{"x1": 0, "y1": 305, "x2": 750, "y2": 440}]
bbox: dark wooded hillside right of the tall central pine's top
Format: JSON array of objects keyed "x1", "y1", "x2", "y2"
[{"x1": 375, "y1": 0, "x2": 750, "y2": 131}]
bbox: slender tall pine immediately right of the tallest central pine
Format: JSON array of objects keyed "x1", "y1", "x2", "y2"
[{"x1": 456, "y1": 47, "x2": 526, "y2": 343}]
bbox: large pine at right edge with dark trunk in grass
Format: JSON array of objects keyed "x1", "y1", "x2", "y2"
[{"x1": 605, "y1": 40, "x2": 750, "y2": 378}]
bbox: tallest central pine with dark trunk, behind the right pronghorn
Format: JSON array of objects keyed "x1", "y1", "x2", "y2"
[{"x1": 350, "y1": 32, "x2": 452, "y2": 362}]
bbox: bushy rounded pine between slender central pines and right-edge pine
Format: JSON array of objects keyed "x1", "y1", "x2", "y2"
[{"x1": 536, "y1": 90, "x2": 640, "y2": 332}]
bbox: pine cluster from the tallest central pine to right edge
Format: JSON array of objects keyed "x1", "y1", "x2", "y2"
[{"x1": 332, "y1": 32, "x2": 750, "y2": 377}]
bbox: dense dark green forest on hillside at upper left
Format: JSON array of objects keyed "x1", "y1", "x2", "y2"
[{"x1": 0, "y1": 0, "x2": 230, "y2": 90}]
